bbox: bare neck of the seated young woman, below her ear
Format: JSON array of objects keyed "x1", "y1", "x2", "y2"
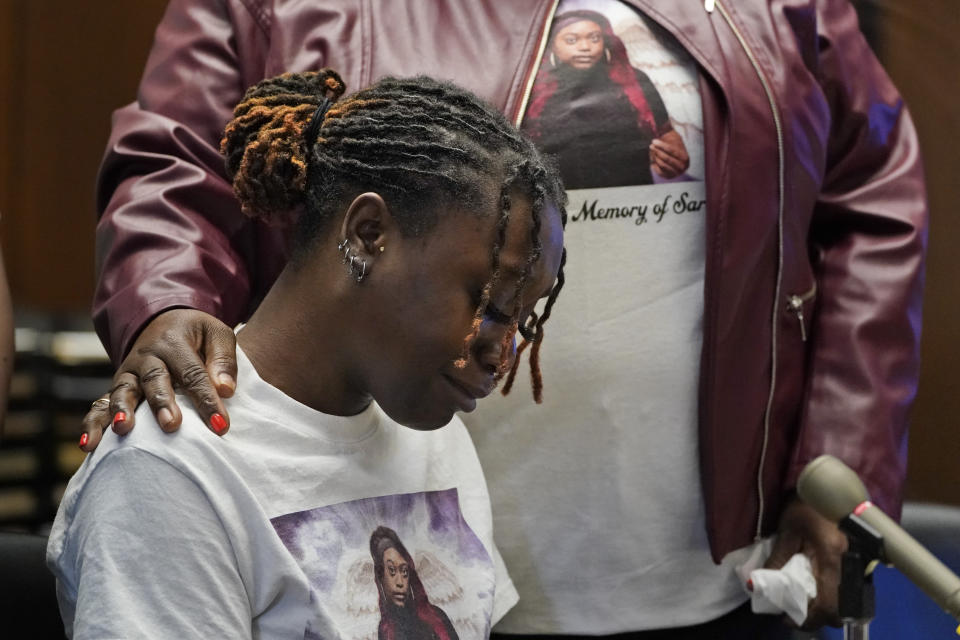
[{"x1": 237, "y1": 266, "x2": 371, "y2": 416}]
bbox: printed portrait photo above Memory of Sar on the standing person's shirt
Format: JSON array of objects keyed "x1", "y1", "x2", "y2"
[{"x1": 522, "y1": 0, "x2": 703, "y2": 190}]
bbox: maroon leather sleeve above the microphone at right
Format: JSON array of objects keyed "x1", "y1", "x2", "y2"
[{"x1": 788, "y1": 0, "x2": 927, "y2": 517}]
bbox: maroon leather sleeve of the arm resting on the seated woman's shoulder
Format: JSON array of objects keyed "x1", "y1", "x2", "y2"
[{"x1": 93, "y1": 0, "x2": 265, "y2": 362}]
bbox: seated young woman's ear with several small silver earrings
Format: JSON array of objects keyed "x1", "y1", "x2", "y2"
[{"x1": 337, "y1": 192, "x2": 399, "y2": 282}]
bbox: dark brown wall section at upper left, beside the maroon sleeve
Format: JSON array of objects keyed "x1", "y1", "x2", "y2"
[{"x1": 0, "y1": 0, "x2": 165, "y2": 313}]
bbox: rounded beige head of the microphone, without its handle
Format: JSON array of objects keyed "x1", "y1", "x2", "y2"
[{"x1": 797, "y1": 455, "x2": 870, "y2": 522}]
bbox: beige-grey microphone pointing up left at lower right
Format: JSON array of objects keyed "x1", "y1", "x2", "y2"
[{"x1": 797, "y1": 455, "x2": 960, "y2": 620}]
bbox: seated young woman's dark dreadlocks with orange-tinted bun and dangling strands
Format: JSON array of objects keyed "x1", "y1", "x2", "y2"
[{"x1": 221, "y1": 69, "x2": 566, "y2": 402}]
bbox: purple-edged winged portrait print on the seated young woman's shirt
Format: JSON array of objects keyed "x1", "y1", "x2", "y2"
[{"x1": 271, "y1": 489, "x2": 495, "y2": 640}]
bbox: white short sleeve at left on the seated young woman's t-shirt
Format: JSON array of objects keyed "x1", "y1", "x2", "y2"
[{"x1": 51, "y1": 448, "x2": 252, "y2": 639}]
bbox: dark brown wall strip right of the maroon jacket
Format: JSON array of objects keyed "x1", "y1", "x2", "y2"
[{"x1": 880, "y1": 0, "x2": 960, "y2": 505}]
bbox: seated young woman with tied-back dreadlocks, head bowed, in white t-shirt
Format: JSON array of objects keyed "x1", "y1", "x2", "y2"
[{"x1": 48, "y1": 70, "x2": 565, "y2": 638}]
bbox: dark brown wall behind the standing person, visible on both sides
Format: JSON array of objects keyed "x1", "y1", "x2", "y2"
[{"x1": 0, "y1": 0, "x2": 960, "y2": 504}]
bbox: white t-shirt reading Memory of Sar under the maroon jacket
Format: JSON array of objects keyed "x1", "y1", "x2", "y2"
[{"x1": 463, "y1": 0, "x2": 747, "y2": 634}]
